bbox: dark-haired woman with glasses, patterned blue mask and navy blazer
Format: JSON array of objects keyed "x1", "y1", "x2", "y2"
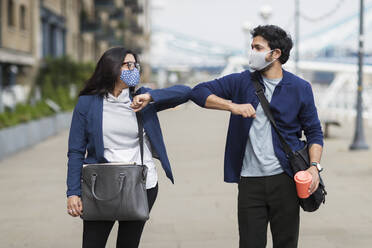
[{"x1": 67, "y1": 47, "x2": 191, "y2": 248}]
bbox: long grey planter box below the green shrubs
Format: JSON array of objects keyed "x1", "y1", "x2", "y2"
[{"x1": 0, "y1": 112, "x2": 72, "y2": 160}]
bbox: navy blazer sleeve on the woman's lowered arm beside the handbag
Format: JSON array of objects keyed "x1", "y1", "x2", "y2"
[{"x1": 66, "y1": 97, "x2": 88, "y2": 196}]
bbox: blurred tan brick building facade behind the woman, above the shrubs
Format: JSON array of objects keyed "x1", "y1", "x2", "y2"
[{"x1": 0, "y1": 0, "x2": 151, "y2": 112}]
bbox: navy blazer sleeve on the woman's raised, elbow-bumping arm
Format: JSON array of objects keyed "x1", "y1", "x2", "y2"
[{"x1": 147, "y1": 85, "x2": 191, "y2": 111}]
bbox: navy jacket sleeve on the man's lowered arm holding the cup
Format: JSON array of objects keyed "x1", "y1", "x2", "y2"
[{"x1": 299, "y1": 83, "x2": 323, "y2": 146}]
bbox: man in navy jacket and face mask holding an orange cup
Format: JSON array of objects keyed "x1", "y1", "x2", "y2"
[{"x1": 192, "y1": 25, "x2": 323, "y2": 248}]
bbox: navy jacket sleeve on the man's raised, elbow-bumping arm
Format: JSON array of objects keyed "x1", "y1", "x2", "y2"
[{"x1": 191, "y1": 73, "x2": 241, "y2": 107}]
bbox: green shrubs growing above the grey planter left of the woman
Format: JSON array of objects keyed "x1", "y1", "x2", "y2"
[{"x1": 0, "y1": 57, "x2": 94, "y2": 129}]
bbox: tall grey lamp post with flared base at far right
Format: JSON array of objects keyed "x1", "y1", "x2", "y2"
[{"x1": 350, "y1": 0, "x2": 368, "y2": 150}]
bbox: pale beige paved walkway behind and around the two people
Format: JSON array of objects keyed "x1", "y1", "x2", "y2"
[{"x1": 0, "y1": 103, "x2": 372, "y2": 248}]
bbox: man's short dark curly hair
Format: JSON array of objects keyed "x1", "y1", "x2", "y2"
[{"x1": 251, "y1": 25, "x2": 293, "y2": 64}]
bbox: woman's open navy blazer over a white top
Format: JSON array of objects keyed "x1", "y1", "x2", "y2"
[{"x1": 67, "y1": 85, "x2": 191, "y2": 196}]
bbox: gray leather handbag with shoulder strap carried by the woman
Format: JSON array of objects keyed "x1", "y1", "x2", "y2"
[{"x1": 81, "y1": 109, "x2": 149, "y2": 221}]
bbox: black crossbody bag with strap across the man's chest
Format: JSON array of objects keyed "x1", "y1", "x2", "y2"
[{"x1": 252, "y1": 78, "x2": 327, "y2": 212}]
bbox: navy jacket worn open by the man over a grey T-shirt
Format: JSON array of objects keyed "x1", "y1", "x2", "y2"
[{"x1": 191, "y1": 70, "x2": 323, "y2": 183}]
